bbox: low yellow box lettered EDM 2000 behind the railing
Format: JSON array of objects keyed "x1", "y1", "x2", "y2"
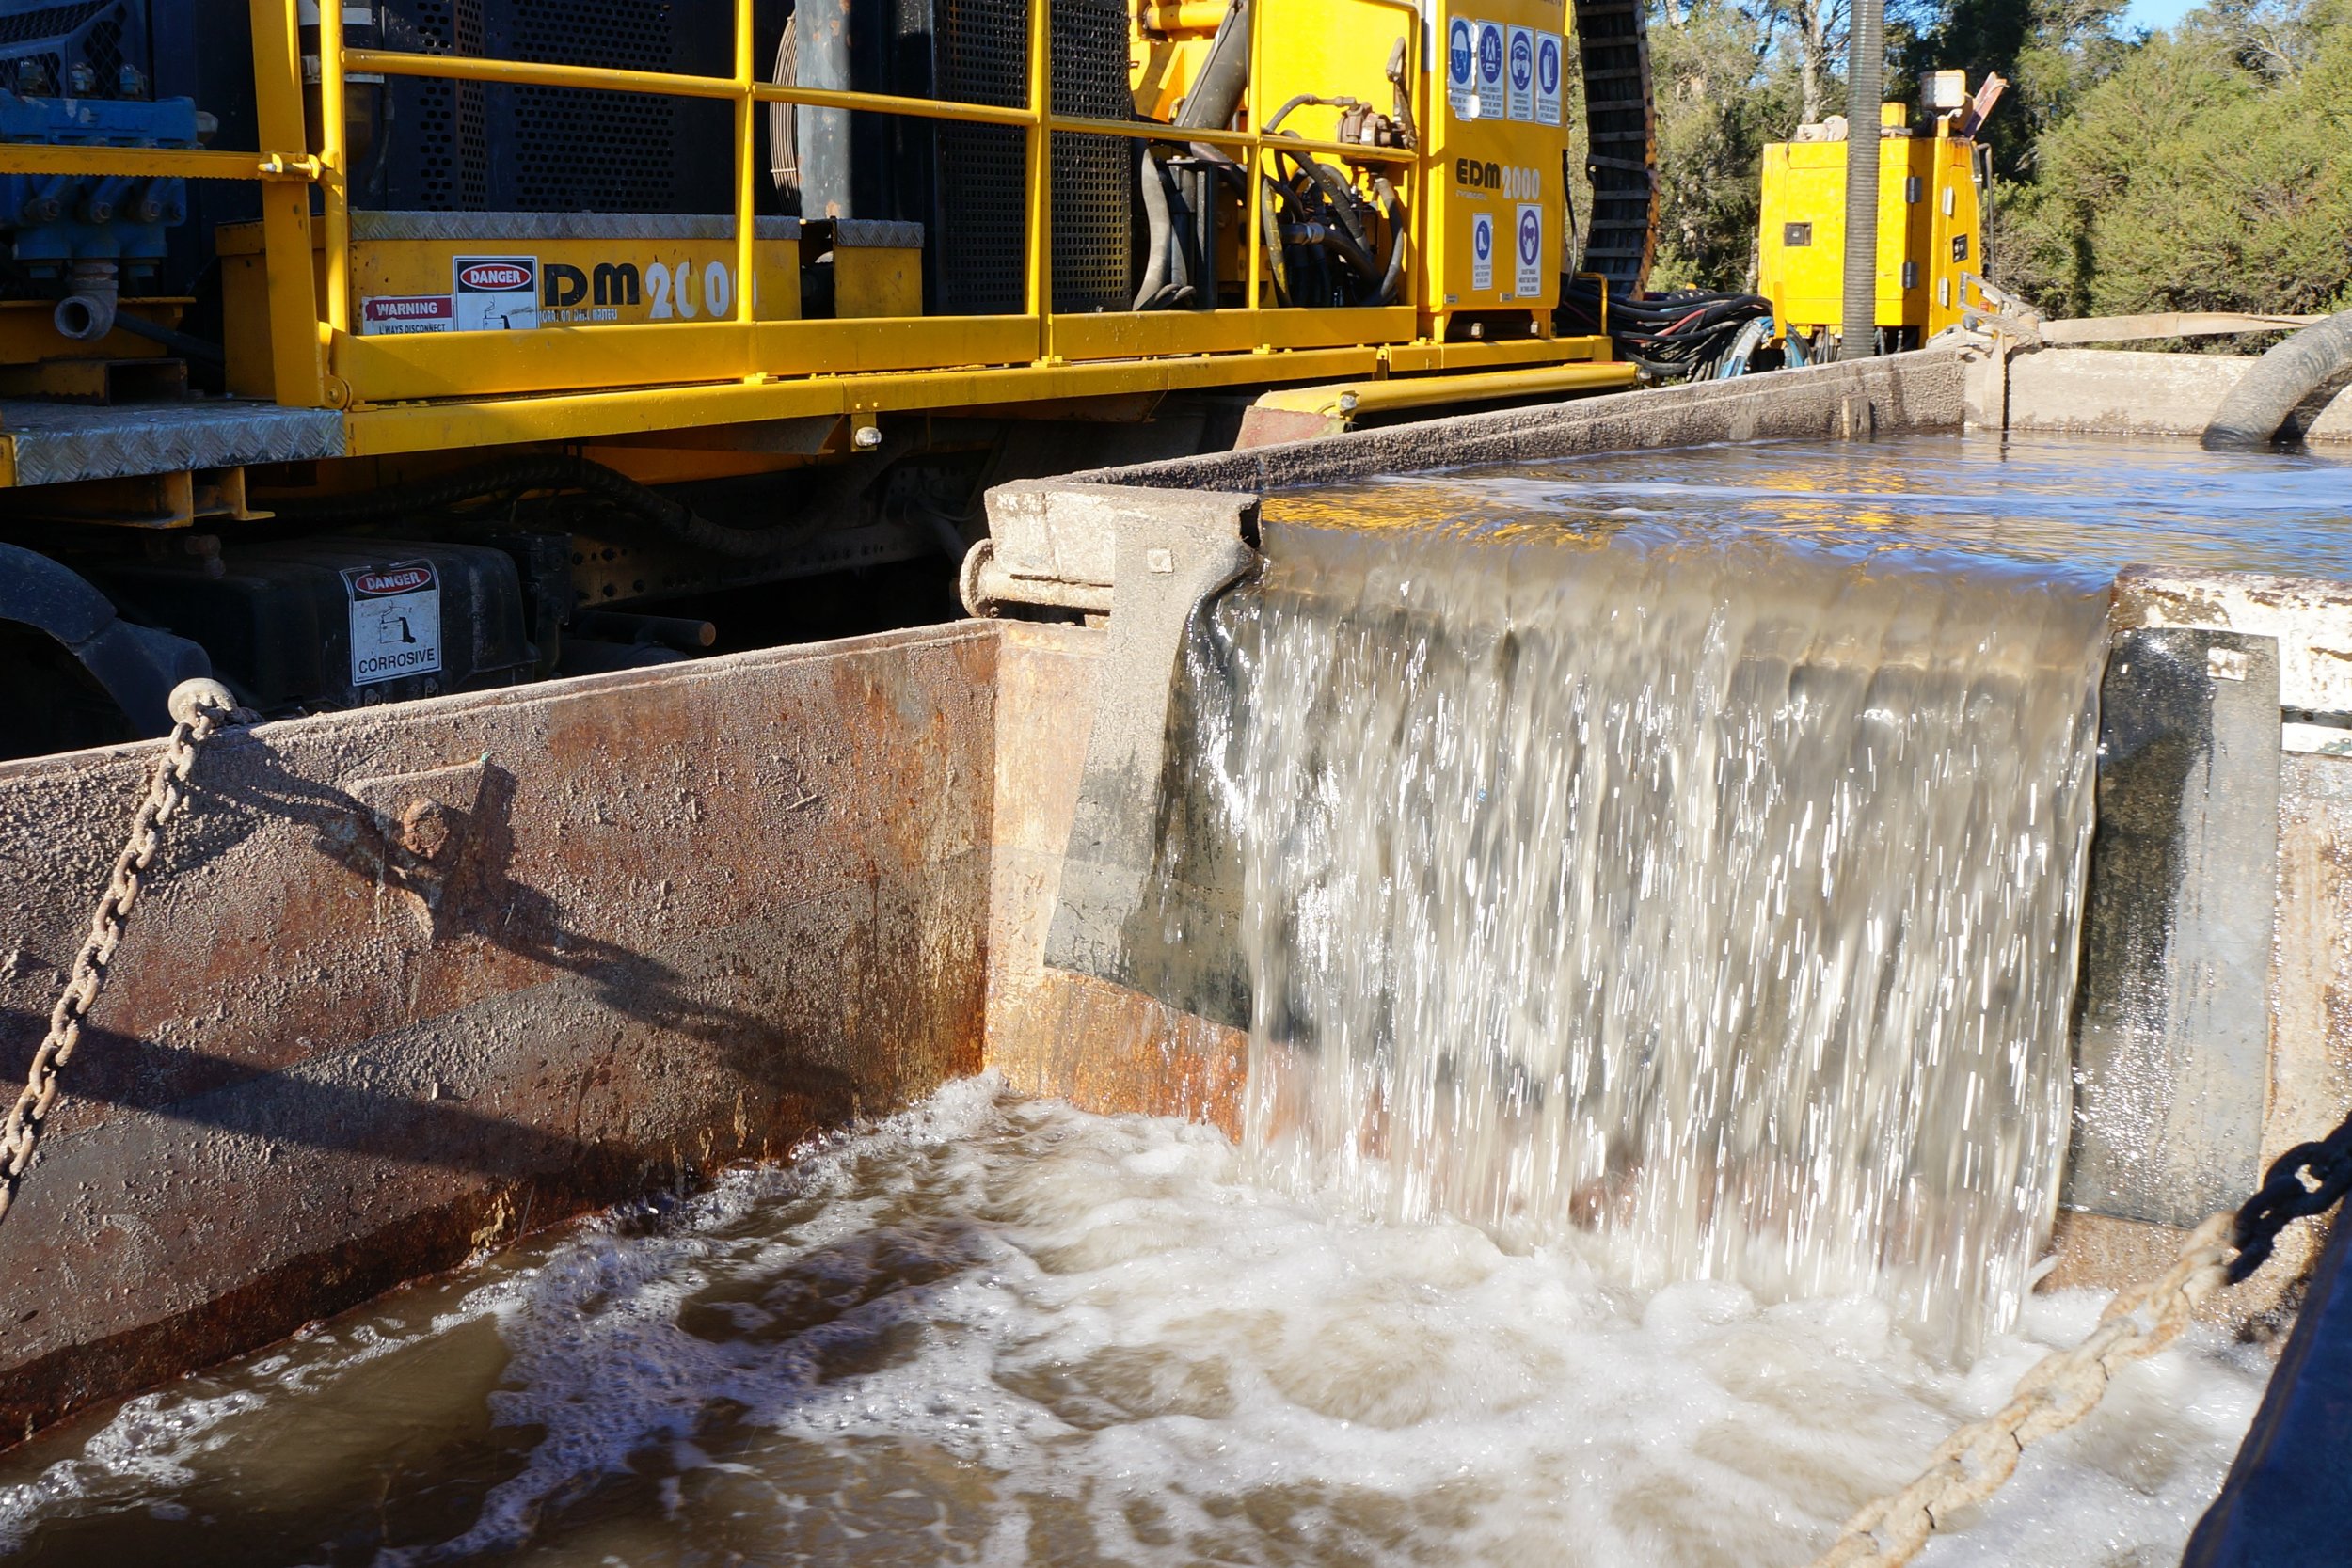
[{"x1": 216, "y1": 212, "x2": 809, "y2": 397}]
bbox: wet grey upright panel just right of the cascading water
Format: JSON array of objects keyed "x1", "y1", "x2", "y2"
[{"x1": 2063, "y1": 627, "x2": 2280, "y2": 1225}]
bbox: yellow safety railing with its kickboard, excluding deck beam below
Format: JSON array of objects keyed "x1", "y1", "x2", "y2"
[{"x1": 0, "y1": 0, "x2": 1430, "y2": 406}]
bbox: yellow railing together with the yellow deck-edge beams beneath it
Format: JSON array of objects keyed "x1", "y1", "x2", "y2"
[{"x1": 0, "y1": 0, "x2": 1607, "y2": 453}]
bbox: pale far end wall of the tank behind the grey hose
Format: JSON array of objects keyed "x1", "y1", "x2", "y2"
[{"x1": 2007, "y1": 348, "x2": 2352, "y2": 442}]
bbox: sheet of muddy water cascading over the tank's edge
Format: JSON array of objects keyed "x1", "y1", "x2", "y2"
[{"x1": 1185, "y1": 524, "x2": 2106, "y2": 1359}]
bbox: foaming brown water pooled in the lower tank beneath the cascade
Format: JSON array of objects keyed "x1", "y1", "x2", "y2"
[{"x1": 0, "y1": 1079, "x2": 2263, "y2": 1568}]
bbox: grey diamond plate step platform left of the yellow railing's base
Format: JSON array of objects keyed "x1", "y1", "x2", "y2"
[{"x1": 0, "y1": 397, "x2": 343, "y2": 486}]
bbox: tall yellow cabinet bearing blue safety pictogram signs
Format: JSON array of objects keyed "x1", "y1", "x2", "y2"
[{"x1": 1425, "y1": 0, "x2": 1569, "y2": 336}]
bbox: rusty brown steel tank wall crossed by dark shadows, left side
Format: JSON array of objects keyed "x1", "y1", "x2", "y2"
[{"x1": 0, "y1": 623, "x2": 1002, "y2": 1436}]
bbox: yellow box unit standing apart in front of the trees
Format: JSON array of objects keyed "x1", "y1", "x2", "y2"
[{"x1": 1757, "y1": 131, "x2": 1985, "y2": 341}]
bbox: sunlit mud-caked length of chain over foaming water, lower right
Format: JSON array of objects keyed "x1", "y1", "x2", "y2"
[{"x1": 1814, "y1": 1213, "x2": 2239, "y2": 1568}]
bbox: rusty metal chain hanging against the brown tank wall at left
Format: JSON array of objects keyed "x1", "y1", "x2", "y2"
[{"x1": 0, "y1": 679, "x2": 243, "y2": 1220}]
